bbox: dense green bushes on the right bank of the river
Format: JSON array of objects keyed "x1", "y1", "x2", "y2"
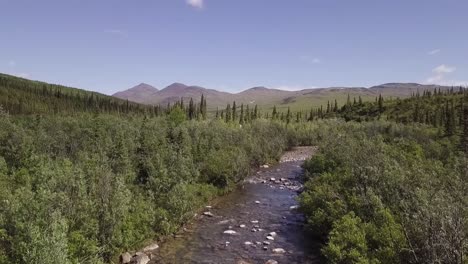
[{"x1": 300, "y1": 121, "x2": 468, "y2": 263}]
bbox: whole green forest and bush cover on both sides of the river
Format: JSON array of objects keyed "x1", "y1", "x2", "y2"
[{"x1": 0, "y1": 75, "x2": 468, "y2": 264}]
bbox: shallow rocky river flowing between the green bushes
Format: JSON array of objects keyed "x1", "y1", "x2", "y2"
[{"x1": 150, "y1": 148, "x2": 321, "y2": 264}]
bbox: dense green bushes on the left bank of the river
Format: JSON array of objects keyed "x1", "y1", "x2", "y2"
[{"x1": 0, "y1": 112, "x2": 287, "y2": 264}]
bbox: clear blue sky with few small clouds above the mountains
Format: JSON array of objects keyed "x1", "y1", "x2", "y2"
[{"x1": 0, "y1": 0, "x2": 468, "y2": 94}]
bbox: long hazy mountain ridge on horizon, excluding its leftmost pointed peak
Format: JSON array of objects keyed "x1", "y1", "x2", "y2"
[{"x1": 114, "y1": 83, "x2": 451, "y2": 110}]
